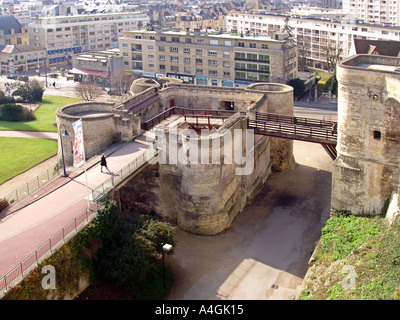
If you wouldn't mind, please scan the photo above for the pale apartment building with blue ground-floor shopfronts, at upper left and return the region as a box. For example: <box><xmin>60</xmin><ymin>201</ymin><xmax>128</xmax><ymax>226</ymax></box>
<box><xmin>28</xmin><ymin>12</ymin><xmax>149</xmax><ymax>64</ymax></box>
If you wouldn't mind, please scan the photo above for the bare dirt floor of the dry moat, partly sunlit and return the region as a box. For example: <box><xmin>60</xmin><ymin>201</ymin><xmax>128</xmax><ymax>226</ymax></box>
<box><xmin>79</xmin><ymin>141</ymin><xmax>333</xmax><ymax>300</ymax></box>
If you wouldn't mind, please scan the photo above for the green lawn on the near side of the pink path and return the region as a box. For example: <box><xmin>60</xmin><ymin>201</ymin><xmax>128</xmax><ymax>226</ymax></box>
<box><xmin>0</xmin><ymin>137</ymin><xmax>58</xmax><ymax>184</ymax></box>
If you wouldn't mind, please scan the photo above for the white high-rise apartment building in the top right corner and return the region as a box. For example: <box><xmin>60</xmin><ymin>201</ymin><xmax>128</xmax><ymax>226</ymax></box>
<box><xmin>342</xmin><ymin>0</ymin><xmax>400</xmax><ymax>26</ymax></box>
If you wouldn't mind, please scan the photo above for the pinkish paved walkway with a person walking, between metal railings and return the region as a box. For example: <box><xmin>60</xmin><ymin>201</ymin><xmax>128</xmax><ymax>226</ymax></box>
<box><xmin>0</xmin><ymin>135</ymin><xmax>152</xmax><ymax>277</ymax></box>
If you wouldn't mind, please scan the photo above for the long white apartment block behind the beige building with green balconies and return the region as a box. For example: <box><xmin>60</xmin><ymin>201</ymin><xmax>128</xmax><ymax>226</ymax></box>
<box><xmin>225</xmin><ymin>11</ymin><xmax>400</xmax><ymax>70</ymax></box>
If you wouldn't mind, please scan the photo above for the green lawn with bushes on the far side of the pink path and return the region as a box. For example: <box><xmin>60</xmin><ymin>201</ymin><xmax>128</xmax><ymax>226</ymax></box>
<box><xmin>0</xmin><ymin>96</ymin><xmax>81</xmax><ymax>132</ymax></box>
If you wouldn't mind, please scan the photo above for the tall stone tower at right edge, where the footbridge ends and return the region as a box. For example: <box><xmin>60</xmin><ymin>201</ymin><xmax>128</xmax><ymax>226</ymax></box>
<box><xmin>332</xmin><ymin>55</ymin><xmax>400</xmax><ymax>215</ymax></box>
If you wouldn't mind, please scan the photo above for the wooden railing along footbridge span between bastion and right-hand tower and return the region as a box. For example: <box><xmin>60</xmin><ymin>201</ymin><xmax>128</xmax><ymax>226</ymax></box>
<box><xmin>249</xmin><ymin>119</ymin><xmax>337</xmax><ymax>145</ymax></box>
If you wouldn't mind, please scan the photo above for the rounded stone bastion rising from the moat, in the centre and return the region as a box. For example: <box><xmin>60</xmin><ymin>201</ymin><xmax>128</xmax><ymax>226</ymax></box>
<box><xmin>156</xmin><ymin>114</ymin><xmax>271</xmax><ymax>235</ymax></box>
